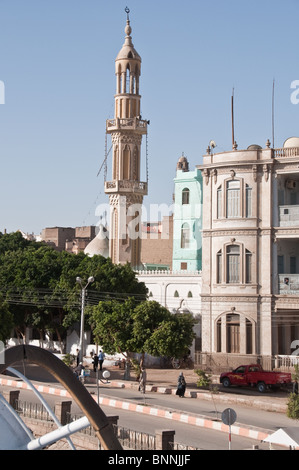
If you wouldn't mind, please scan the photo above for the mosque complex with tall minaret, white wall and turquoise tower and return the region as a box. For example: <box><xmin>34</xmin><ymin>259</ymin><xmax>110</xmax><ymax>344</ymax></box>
<box><xmin>84</xmin><ymin>10</ymin><xmax>202</xmax><ymax>360</ymax></box>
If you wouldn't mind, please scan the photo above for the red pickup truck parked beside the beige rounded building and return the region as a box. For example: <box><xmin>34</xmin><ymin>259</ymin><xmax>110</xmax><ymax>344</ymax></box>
<box><xmin>220</xmin><ymin>364</ymin><xmax>292</xmax><ymax>393</ymax></box>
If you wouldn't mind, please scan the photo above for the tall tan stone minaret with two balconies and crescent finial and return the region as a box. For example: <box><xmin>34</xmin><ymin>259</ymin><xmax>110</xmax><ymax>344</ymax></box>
<box><xmin>105</xmin><ymin>8</ymin><xmax>148</xmax><ymax>268</ymax></box>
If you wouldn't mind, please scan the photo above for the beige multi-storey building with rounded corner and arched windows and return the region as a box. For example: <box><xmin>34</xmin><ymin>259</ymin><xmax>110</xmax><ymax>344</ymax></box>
<box><xmin>198</xmin><ymin>142</ymin><xmax>299</xmax><ymax>364</ymax></box>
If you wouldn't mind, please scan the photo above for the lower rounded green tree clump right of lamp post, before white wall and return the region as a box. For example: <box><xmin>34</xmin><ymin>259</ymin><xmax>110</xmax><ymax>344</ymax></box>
<box><xmin>88</xmin><ymin>299</ymin><xmax>196</xmax><ymax>365</ymax></box>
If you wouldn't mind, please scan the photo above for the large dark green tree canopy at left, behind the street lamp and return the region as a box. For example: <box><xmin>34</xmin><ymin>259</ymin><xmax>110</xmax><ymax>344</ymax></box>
<box><xmin>0</xmin><ymin>233</ymin><xmax>147</xmax><ymax>344</ymax></box>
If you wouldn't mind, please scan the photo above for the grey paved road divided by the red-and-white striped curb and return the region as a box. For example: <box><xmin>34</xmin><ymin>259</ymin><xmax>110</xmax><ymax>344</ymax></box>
<box><xmin>2</xmin><ymin>364</ymin><xmax>294</xmax><ymax>450</ymax></box>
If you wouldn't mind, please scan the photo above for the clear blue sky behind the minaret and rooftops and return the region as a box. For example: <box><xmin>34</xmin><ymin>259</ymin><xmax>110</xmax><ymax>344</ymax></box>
<box><xmin>0</xmin><ymin>0</ymin><xmax>299</xmax><ymax>234</ymax></box>
